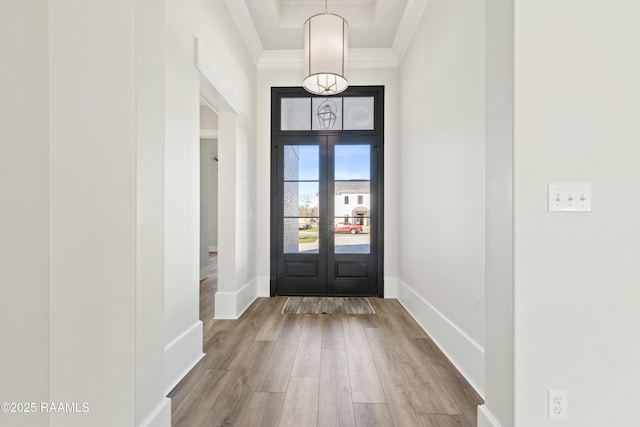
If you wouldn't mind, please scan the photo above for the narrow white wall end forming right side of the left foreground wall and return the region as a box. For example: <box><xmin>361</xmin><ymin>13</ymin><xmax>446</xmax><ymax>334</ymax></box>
<box><xmin>135</xmin><ymin>0</ymin><xmax>171</xmax><ymax>427</ymax></box>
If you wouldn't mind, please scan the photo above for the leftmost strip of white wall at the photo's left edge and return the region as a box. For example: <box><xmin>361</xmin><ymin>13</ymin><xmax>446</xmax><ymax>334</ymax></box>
<box><xmin>0</xmin><ymin>1</ymin><xmax>49</xmax><ymax>426</ymax></box>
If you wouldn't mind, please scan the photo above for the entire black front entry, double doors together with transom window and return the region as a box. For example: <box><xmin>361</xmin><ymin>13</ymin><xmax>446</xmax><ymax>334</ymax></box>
<box><xmin>271</xmin><ymin>86</ymin><xmax>384</xmax><ymax>297</ymax></box>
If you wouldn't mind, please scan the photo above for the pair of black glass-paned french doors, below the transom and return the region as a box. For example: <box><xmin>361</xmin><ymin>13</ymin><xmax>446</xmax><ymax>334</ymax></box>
<box><xmin>271</xmin><ymin>86</ymin><xmax>383</xmax><ymax>296</ymax></box>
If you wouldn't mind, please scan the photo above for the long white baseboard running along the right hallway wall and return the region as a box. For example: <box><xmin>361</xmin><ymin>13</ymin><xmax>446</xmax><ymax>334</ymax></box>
<box><xmin>398</xmin><ymin>279</ymin><xmax>484</xmax><ymax>396</ymax></box>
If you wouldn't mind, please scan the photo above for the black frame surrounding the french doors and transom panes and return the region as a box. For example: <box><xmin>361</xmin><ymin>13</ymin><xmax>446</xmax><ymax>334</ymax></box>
<box><xmin>269</xmin><ymin>86</ymin><xmax>384</xmax><ymax>298</ymax></box>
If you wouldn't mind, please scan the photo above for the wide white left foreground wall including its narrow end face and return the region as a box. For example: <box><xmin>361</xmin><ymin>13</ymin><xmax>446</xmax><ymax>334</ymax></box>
<box><xmin>49</xmin><ymin>0</ymin><xmax>168</xmax><ymax>426</ymax></box>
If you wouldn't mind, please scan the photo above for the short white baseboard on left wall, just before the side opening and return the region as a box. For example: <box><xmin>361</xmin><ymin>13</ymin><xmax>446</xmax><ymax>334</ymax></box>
<box><xmin>164</xmin><ymin>320</ymin><xmax>204</xmax><ymax>396</ymax></box>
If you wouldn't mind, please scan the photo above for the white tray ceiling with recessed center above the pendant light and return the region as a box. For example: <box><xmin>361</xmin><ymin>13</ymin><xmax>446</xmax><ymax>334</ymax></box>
<box><xmin>225</xmin><ymin>0</ymin><xmax>428</xmax><ymax>64</ymax></box>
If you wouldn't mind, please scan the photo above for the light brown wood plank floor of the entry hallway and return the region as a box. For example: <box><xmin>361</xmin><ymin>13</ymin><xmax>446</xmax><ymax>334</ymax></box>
<box><xmin>169</xmin><ymin>297</ymin><xmax>482</xmax><ymax>427</ymax></box>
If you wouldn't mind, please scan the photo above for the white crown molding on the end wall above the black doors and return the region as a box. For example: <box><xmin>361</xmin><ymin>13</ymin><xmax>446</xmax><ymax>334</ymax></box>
<box><xmin>258</xmin><ymin>48</ymin><xmax>400</xmax><ymax>70</ymax></box>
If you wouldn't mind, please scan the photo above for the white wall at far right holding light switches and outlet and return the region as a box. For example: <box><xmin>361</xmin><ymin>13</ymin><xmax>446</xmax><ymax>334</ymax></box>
<box><xmin>514</xmin><ymin>0</ymin><xmax>640</xmax><ymax>427</ymax></box>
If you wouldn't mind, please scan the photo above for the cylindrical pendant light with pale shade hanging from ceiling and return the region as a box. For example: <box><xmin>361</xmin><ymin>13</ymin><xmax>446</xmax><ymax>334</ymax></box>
<box><xmin>302</xmin><ymin>0</ymin><xmax>349</xmax><ymax>95</ymax></box>
